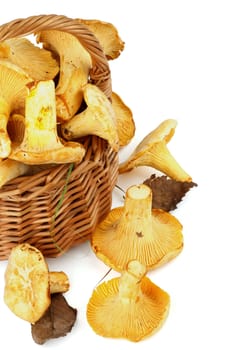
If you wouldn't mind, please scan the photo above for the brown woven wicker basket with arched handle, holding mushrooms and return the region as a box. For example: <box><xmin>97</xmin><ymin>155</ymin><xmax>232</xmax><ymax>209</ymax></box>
<box><xmin>0</xmin><ymin>15</ymin><xmax>118</xmax><ymax>260</ymax></box>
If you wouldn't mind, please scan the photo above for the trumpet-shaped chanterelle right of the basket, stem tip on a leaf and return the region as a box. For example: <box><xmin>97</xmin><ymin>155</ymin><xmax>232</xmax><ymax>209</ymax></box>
<box><xmin>119</xmin><ymin>119</ymin><xmax>192</xmax><ymax>182</ymax></box>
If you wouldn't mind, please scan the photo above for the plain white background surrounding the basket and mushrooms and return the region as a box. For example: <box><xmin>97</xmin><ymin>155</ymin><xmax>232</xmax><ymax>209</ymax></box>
<box><xmin>0</xmin><ymin>0</ymin><xmax>242</xmax><ymax>350</ymax></box>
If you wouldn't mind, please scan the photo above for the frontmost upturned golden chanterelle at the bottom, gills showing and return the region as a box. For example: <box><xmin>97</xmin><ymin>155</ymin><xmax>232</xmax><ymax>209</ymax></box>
<box><xmin>87</xmin><ymin>260</ymin><xmax>170</xmax><ymax>342</ymax></box>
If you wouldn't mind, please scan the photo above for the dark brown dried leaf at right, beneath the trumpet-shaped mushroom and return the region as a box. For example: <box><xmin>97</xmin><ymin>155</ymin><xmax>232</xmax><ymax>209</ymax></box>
<box><xmin>144</xmin><ymin>174</ymin><xmax>197</xmax><ymax>212</ymax></box>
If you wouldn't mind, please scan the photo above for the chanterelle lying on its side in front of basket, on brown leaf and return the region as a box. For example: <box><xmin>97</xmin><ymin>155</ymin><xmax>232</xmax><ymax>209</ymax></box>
<box><xmin>4</xmin><ymin>243</ymin><xmax>69</xmax><ymax>323</ymax></box>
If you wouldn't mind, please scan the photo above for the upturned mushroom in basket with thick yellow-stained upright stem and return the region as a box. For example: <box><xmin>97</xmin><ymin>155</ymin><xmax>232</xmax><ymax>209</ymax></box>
<box><xmin>9</xmin><ymin>80</ymin><xmax>85</xmax><ymax>164</ymax></box>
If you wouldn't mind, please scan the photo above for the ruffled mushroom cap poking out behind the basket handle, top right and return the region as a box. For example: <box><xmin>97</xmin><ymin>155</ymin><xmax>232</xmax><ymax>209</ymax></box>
<box><xmin>78</xmin><ymin>19</ymin><xmax>124</xmax><ymax>60</ymax></box>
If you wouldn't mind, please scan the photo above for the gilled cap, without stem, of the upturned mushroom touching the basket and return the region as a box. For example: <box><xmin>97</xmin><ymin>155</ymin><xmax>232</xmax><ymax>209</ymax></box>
<box><xmin>91</xmin><ymin>207</ymin><xmax>183</xmax><ymax>271</ymax></box>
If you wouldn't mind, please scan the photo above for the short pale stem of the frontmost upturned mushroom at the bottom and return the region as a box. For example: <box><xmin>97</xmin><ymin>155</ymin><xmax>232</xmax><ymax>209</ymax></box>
<box><xmin>119</xmin><ymin>260</ymin><xmax>146</xmax><ymax>304</ymax></box>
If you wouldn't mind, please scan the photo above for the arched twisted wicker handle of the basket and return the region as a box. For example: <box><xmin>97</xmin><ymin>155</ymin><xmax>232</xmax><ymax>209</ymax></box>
<box><xmin>0</xmin><ymin>15</ymin><xmax>112</xmax><ymax>99</ymax></box>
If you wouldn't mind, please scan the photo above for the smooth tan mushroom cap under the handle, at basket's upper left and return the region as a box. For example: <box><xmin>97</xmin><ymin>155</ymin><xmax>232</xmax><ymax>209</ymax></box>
<box><xmin>0</xmin><ymin>38</ymin><xmax>59</xmax><ymax>80</ymax></box>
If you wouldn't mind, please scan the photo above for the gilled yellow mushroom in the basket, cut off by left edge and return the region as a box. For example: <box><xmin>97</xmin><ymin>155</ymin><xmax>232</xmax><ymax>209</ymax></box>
<box><xmin>0</xmin><ymin>59</ymin><xmax>32</xmax><ymax>158</ymax></box>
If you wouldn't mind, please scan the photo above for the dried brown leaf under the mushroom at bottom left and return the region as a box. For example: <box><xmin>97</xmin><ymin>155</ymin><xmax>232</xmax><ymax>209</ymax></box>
<box><xmin>31</xmin><ymin>293</ymin><xmax>77</xmax><ymax>345</ymax></box>
